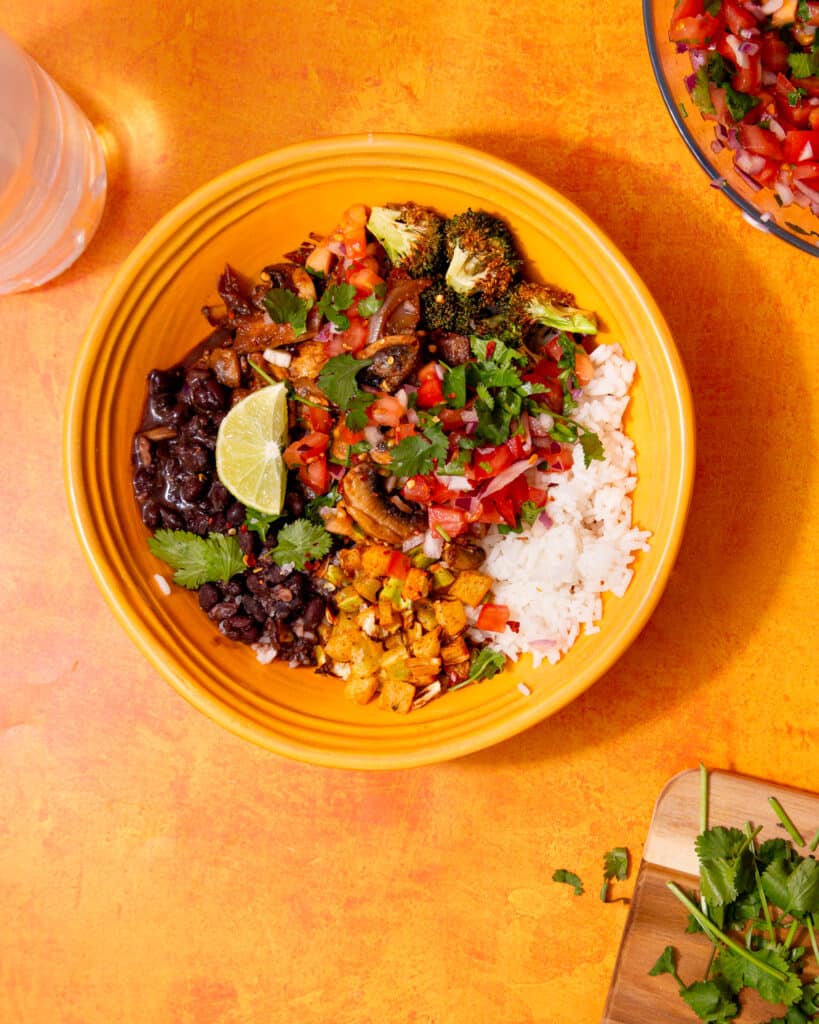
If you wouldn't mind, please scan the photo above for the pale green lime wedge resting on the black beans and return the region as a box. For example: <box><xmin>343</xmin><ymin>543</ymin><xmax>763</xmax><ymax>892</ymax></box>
<box><xmin>216</xmin><ymin>383</ymin><xmax>288</xmax><ymax>515</ymax></box>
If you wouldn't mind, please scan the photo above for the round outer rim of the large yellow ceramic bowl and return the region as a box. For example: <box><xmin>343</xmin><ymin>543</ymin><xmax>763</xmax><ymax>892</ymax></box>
<box><xmin>63</xmin><ymin>132</ymin><xmax>695</xmax><ymax>770</ymax></box>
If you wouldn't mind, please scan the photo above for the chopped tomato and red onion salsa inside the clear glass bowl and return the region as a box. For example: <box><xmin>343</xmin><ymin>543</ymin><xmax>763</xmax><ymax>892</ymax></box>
<box><xmin>670</xmin><ymin>0</ymin><xmax>819</xmax><ymax>213</ymax></box>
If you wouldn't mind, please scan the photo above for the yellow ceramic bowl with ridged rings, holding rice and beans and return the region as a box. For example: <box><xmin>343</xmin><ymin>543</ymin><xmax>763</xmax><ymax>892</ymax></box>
<box><xmin>66</xmin><ymin>135</ymin><xmax>693</xmax><ymax>768</ymax></box>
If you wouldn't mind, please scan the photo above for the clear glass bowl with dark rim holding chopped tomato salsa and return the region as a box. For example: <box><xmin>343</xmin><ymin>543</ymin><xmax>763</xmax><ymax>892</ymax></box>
<box><xmin>643</xmin><ymin>0</ymin><xmax>819</xmax><ymax>256</ymax></box>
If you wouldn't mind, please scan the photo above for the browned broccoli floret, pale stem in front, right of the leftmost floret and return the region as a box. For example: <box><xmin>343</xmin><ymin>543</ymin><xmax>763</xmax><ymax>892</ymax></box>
<box><xmin>444</xmin><ymin>210</ymin><xmax>520</xmax><ymax>302</ymax></box>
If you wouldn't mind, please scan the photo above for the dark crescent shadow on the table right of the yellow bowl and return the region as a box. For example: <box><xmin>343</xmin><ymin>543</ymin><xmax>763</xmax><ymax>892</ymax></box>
<box><xmin>455</xmin><ymin>128</ymin><xmax>816</xmax><ymax>767</ymax></box>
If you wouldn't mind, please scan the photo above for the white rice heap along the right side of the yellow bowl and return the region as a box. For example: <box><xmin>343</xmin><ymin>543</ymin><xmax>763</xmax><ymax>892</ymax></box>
<box><xmin>471</xmin><ymin>345</ymin><xmax>650</xmax><ymax>668</ymax></box>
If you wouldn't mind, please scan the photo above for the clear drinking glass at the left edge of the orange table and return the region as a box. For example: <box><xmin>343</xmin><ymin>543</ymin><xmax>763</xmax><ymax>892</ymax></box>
<box><xmin>0</xmin><ymin>31</ymin><xmax>106</xmax><ymax>295</ymax></box>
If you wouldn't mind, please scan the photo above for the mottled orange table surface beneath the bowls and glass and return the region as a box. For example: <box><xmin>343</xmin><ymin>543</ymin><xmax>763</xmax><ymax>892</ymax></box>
<box><xmin>0</xmin><ymin>0</ymin><xmax>819</xmax><ymax>1024</ymax></box>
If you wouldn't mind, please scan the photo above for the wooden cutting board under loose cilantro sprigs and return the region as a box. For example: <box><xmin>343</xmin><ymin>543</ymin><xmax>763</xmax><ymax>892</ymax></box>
<box><xmin>602</xmin><ymin>770</ymin><xmax>819</xmax><ymax>1024</ymax></box>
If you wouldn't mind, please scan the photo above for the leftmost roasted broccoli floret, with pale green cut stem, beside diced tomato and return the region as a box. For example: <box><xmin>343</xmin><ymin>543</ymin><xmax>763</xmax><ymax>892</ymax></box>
<box><xmin>367</xmin><ymin>203</ymin><xmax>443</xmax><ymax>278</ymax></box>
